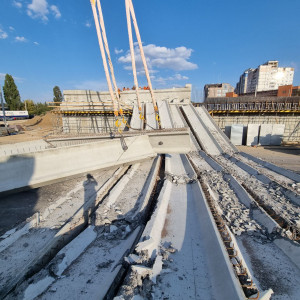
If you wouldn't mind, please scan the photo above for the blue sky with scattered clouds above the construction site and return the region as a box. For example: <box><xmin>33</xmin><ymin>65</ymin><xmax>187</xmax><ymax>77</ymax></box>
<box><xmin>0</xmin><ymin>0</ymin><xmax>300</xmax><ymax>102</ymax></box>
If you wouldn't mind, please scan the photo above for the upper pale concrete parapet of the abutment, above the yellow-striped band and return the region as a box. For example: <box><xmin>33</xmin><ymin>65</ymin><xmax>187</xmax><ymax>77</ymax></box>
<box><xmin>64</xmin><ymin>84</ymin><xmax>192</xmax><ymax>105</ymax></box>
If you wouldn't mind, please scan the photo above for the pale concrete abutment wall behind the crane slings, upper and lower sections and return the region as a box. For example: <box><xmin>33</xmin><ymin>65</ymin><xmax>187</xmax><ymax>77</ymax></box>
<box><xmin>60</xmin><ymin>84</ymin><xmax>192</xmax><ymax>134</ymax></box>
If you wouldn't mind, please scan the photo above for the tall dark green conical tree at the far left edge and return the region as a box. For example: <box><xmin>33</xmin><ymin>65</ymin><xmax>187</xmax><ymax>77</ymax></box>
<box><xmin>3</xmin><ymin>74</ymin><xmax>22</xmax><ymax>110</ymax></box>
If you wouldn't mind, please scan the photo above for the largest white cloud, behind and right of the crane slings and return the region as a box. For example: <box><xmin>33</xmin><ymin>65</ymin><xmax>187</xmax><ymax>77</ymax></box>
<box><xmin>118</xmin><ymin>44</ymin><xmax>198</xmax><ymax>71</ymax></box>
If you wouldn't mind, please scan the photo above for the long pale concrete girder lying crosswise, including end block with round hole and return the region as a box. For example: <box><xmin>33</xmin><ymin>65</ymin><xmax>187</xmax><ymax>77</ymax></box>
<box><xmin>0</xmin><ymin>129</ymin><xmax>191</xmax><ymax>193</ymax></box>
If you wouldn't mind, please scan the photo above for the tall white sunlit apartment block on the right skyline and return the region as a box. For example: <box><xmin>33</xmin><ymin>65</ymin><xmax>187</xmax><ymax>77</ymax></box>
<box><xmin>236</xmin><ymin>60</ymin><xmax>294</xmax><ymax>94</ymax></box>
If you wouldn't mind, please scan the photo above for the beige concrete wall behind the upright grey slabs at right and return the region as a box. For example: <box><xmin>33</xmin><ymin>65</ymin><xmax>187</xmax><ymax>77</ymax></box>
<box><xmin>213</xmin><ymin>115</ymin><xmax>300</xmax><ymax>143</ymax></box>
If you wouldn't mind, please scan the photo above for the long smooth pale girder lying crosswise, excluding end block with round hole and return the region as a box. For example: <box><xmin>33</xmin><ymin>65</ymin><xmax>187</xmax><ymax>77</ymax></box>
<box><xmin>0</xmin><ymin>135</ymin><xmax>156</xmax><ymax>192</ymax></box>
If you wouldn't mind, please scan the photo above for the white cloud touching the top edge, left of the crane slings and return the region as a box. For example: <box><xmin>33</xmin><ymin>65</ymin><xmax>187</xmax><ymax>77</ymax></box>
<box><xmin>27</xmin><ymin>0</ymin><xmax>61</xmax><ymax>22</ymax></box>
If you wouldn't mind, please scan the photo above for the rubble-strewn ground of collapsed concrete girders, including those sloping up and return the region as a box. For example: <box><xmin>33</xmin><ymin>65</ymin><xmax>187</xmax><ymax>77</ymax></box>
<box><xmin>0</xmin><ymin>105</ymin><xmax>300</xmax><ymax>300</ymax></box>
